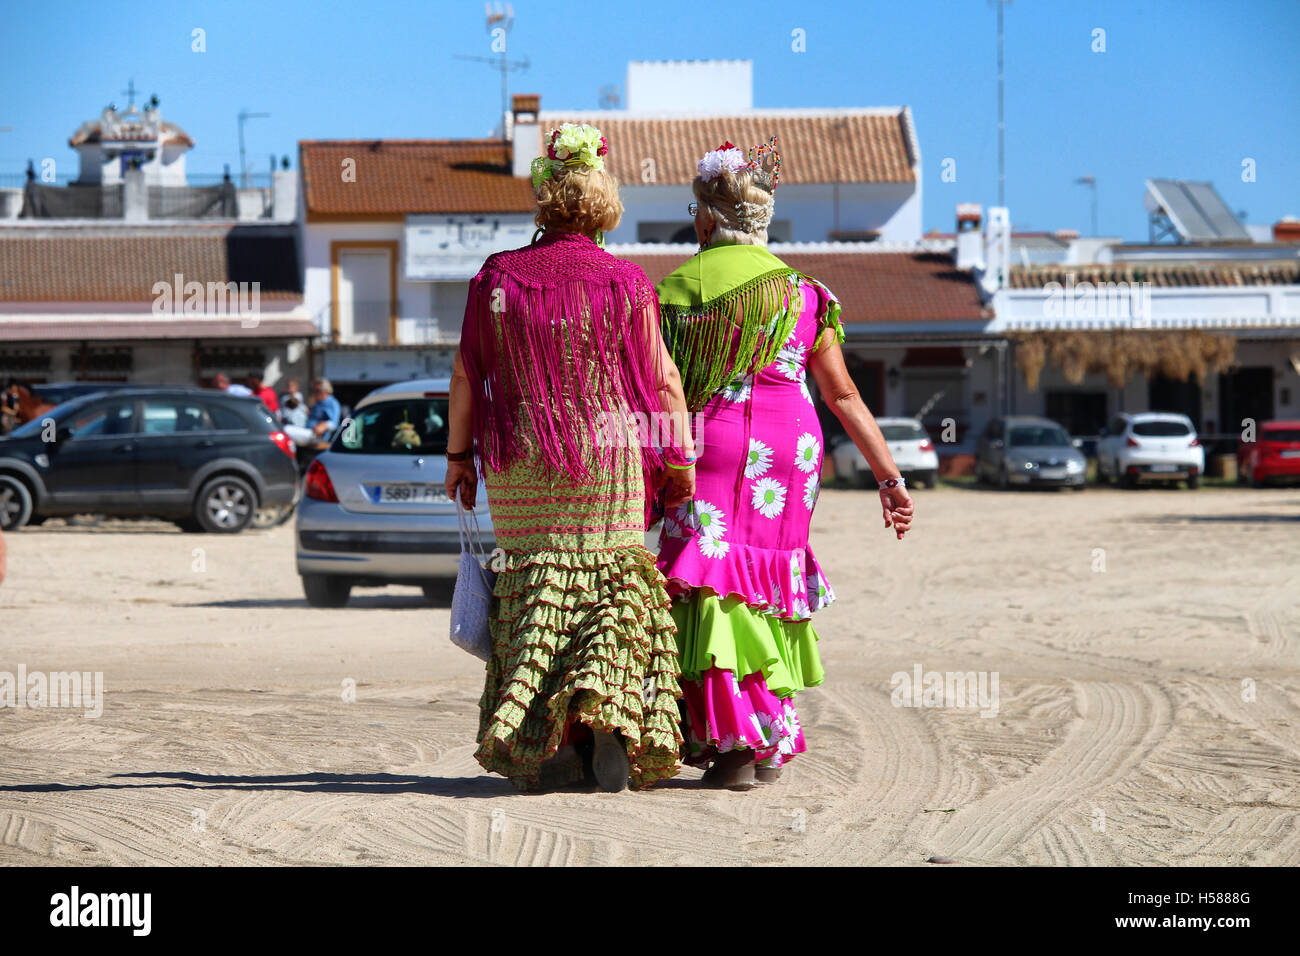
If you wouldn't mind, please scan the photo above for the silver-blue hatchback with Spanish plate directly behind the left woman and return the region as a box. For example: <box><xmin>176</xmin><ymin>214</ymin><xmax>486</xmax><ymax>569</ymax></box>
<box><xmin>295</xmin><ymin>378</ymin><xmax>495</xmax><ymax>607</ymax></box>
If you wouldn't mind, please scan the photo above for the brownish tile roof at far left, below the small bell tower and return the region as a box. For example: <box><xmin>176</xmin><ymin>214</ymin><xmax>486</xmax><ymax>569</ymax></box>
<box><xmin>0</xmin><ymin>224</ymin><xmax>303</xmax><ymax>302</ymax></box>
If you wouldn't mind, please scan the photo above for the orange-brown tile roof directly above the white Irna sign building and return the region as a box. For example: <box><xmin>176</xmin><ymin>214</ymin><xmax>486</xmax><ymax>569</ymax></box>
<box><xmin>298</xmin><ymin>139</ymin><xmax>537</xmax><ymax>221</ymax></box>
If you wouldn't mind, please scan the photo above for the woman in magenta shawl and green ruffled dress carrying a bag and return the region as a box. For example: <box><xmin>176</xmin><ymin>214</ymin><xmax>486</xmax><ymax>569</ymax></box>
<box><xmin>447</xmin><ymin>125</ymin><xmax>693</xmax><ymax>791</ymax></box>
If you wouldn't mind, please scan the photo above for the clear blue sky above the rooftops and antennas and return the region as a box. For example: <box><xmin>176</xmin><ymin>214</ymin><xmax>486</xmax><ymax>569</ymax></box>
<box><xmin>0</xmin><ymin>0</ymin><xmax>1300</xmax><ymax>241</ymax></box>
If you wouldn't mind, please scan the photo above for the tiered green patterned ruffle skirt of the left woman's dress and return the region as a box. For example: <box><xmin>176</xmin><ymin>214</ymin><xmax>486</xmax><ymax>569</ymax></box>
<box><xmin>475</xmin><ymin>546</ymin><xmax>683</xmax><ymax>790</ymax></box>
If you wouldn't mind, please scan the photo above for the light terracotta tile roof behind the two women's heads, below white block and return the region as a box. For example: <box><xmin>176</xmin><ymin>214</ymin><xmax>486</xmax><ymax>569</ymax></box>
<box><xmin>540</xmin><ymin>107</ymin><xmax>917</xmax><ymax>185</ymax></box>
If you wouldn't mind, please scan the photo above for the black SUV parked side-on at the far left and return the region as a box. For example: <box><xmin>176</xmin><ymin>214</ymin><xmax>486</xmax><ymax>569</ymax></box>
<box><xmin>0</xmin><ymin>388</ymin><xmax>298</xmax><ymax>533</ymax></box>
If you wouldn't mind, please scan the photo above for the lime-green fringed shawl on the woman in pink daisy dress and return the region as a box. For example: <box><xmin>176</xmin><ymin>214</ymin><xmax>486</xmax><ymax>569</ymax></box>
<box><xmin>655</xmin><ymin>245</ymin><xmax>841</xmax><ymax>411</ymax></box>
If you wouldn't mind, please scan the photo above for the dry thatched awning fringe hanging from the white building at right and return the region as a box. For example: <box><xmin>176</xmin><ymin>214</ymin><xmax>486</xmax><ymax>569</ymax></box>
<box><xmin>1009</xmin><ymin>329</ymin><xmax>1236</xmax><ymax>392</ymax></box>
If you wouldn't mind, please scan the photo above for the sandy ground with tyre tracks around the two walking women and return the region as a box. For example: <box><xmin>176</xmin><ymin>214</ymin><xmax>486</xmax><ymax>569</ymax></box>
<box><xmin>0</xmin><ymin>488</ymin><xmax>1300</xmax><ymax>865</ymax></box>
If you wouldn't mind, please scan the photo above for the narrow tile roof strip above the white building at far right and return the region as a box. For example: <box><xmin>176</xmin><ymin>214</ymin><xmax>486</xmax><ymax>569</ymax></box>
<box><xmin>1008</xmin><ymin>259</ymin><xmax>1300</xmax><ymax>289</ymax></box>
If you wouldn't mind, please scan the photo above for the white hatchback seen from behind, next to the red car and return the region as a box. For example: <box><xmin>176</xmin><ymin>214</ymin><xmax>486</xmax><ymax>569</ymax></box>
<box><xmin>1097</xmin><ymin>411</ymin><xmax>1205</xmax><ymax>488</ymax></box>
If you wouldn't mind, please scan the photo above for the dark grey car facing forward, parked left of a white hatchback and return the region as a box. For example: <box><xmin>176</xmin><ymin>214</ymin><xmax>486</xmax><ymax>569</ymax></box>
<box><xmin>975</xmin><ymin>415</ymin><xmax>1088</xmax><ymax>490</ymax></box>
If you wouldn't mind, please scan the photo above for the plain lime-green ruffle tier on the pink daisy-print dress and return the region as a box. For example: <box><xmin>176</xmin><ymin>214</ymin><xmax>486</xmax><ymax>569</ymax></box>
<box><xmin>672</xmin><ymin>591</ymin><xmax>826</xmax><ymax>700</ymax></box>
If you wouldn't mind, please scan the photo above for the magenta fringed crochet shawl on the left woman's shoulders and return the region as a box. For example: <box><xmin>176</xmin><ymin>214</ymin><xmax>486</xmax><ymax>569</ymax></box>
<box><xmin>460</xmin><ymin>233</ymin><xmax>662</xmax><ymax>481</ymax></box>
